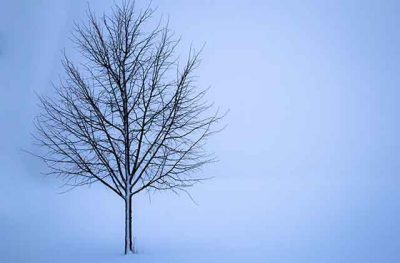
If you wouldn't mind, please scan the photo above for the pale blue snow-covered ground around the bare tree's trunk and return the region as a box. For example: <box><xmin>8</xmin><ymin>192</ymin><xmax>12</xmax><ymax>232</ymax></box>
<box><xmin>0</xmin><ymin>148</ymin><xmax>400</xmax><ymax>263</ymax></box>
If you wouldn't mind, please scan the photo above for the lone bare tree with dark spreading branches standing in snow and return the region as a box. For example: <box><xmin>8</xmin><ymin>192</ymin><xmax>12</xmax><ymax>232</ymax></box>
<box><xmin>35</xmin><ymin>3</ymin><xmax>221</xmax><ymax>254</ymax></box>
